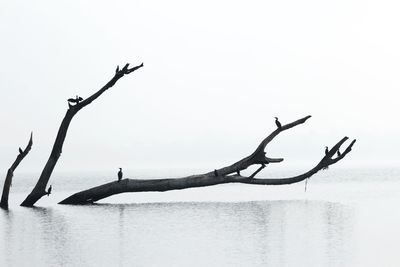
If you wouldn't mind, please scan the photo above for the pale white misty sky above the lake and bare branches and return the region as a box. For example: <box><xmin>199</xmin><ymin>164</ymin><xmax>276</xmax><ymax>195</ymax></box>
<box><xmin>0</xmin><ymin>0</ymin><xmax>400</xmax><ymax>173</ymax></box>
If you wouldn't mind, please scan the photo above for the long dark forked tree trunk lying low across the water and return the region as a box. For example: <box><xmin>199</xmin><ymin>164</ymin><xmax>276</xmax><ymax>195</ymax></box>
<box><xmin>59</xmin><ymin>116</ymin><xmax>356</xmax><ymax>205</ymax></box>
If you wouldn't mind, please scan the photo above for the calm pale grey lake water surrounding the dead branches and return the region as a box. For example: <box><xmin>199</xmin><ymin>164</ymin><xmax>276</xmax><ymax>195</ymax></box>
<box><xmin>0</xmin><ymin>168</ymin><xmax>400</xmax><ymax>267</ymax></box>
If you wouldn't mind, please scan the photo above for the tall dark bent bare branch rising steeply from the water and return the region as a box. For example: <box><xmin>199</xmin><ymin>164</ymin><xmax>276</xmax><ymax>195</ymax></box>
<box><xmin>21</xmin><ymin>63</ymin><xmax>143</xmax><ymax>207</ymax></box>
